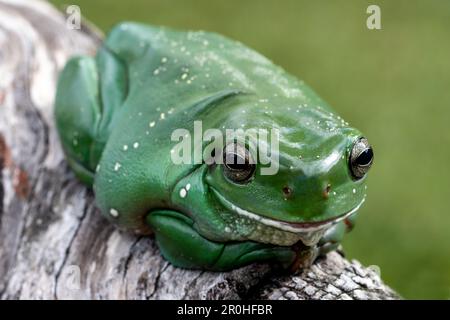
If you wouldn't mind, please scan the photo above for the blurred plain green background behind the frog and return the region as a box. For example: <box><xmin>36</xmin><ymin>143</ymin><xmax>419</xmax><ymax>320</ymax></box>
<box><xmin>51</xmin><ymin>0</ymin><xmax>450</xmax><ymax>299</ymax></box>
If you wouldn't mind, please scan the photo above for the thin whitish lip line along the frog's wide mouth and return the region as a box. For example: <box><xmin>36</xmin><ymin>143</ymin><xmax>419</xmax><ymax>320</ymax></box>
<box><xmin>210</xmin><ymin>187</ymin><xmax>366</xmax><ymax>233</ymax></box>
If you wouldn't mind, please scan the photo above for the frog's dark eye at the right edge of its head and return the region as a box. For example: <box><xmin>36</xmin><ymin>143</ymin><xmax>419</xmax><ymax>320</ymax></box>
<box><xmin>349</xmin><ymin>138</ymin><xmax>373</xmax><ymax>180</ymax></box>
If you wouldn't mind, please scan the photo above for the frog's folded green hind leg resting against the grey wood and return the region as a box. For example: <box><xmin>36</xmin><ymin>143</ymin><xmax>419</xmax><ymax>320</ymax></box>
<box><xmin>55</xmin><ymin>49</ymin><xmax>127</xmax><ymax>185</ymax></box>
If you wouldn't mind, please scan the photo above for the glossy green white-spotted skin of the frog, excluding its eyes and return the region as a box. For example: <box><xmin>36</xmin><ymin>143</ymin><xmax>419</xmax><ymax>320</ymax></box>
<box><xmin>55</xmin><ymin>23</ymin><xmax>372</xmax><ymax>270</ymax></box>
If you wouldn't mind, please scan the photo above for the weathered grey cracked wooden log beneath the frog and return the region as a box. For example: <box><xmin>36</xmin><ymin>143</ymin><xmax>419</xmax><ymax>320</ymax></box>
<box><xmin>0</xmin><ymin>0</ymin><xmax>398</xmax><ymax>299</ymax></box>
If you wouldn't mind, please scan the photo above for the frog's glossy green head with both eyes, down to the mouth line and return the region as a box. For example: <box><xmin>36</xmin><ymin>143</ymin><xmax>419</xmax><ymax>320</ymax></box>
<box><xmin>205</xmin><ymin>96</ymin><xmax>373</xmax><ymax>239</ymax></box>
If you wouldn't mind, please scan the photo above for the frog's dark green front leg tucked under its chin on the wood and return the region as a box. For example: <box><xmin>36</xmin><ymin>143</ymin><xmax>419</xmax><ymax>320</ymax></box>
<box><xmin>147</xmin><ymin>211</ymin><xmax>296</xmax><ymax>271</ymax></box>
